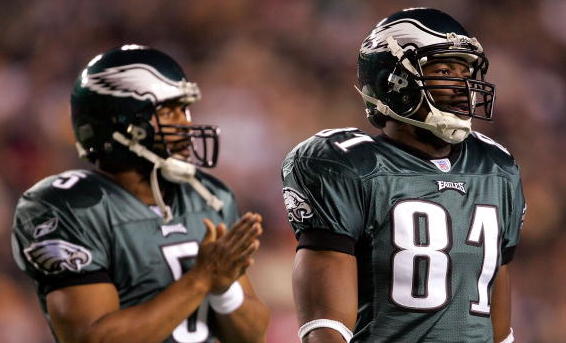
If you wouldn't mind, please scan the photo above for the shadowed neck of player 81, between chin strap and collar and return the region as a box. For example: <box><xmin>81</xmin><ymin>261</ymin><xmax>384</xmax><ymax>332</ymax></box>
<box><xmin>383</xmin><ymin>121</ymin><xmax>452</xmax><ymax>158</ymax></box>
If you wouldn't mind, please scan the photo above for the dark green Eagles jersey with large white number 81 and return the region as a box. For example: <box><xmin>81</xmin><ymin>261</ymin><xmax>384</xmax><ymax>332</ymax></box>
<box><xmin>282</xmin><ymin>128</ymin><xmax>525</xmax><ymax>343</ymax></box>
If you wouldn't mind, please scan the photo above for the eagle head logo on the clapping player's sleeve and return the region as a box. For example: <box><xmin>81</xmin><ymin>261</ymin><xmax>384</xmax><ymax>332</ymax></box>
<box><xmin>24</xmin><ymin>239</ymin><xmax>92</xmax><ymax>274</ymax></box>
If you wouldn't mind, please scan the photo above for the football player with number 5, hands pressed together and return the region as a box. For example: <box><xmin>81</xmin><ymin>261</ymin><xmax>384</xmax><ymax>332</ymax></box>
<box><xmin>13</xmin><ymin>45</ymin><xmax>269</xmax><ymax>343</ymax></box>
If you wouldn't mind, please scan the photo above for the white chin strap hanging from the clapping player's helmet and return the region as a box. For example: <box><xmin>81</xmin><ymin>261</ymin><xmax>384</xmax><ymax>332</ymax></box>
<box><xmin>112</xmin><ymin>131</ymin><xmax>224</xmax><ymax>223</ymax></box>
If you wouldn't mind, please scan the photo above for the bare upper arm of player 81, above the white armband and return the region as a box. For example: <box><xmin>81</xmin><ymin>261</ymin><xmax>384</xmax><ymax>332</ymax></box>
<box><xmin>293</xmin><ymin>249</ymin><xmax>358</xmax><ymax>335</ymax></box>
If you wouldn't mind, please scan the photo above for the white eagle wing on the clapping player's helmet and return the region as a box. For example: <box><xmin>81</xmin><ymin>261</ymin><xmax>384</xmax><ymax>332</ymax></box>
<box><xmin>82</xmin><ymin>63</ymin><xmax>200</xmax><ymax>104</ymax></box>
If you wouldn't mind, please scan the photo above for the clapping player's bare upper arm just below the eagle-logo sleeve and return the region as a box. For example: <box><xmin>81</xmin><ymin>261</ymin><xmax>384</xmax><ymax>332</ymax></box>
<box><xmin>47</xmin><ymin>283</ymin><xmax>120</xmax><ymax>343</ymax></box>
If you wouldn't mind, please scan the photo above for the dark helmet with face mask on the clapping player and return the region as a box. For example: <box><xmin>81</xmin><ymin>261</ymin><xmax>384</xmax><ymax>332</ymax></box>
<box><xmin>71</xmin><ymin>45</ymin><xmax>219</xmax><ymax>167</ymax></box>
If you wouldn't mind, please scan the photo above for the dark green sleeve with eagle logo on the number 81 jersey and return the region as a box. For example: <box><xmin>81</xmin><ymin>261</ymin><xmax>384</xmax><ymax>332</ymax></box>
<box><xmin>282</xmin><ymin>158</ymin><xmax>365</xmax><ymax>252</ymax></box>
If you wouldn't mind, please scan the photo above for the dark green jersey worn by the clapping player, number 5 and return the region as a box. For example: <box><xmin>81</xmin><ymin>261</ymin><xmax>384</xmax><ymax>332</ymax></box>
<box><xmin>13</xmin><ymin>170</ymin><xmax>238</xmax><ymax>342</ymax></box>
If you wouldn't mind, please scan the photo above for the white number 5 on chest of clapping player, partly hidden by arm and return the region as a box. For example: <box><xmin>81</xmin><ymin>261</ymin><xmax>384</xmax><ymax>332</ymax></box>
<box><xmin>161</xmin><ymin>241</ymin><xmax>209</xmax><ymax>343</ymax></box>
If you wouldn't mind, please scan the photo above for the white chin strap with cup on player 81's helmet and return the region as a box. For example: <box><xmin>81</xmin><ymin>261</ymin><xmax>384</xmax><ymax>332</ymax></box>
<box><xmin>354</xmin><ymin>86</ymin><xmax>472</xmax><ymax>144</ymax></box>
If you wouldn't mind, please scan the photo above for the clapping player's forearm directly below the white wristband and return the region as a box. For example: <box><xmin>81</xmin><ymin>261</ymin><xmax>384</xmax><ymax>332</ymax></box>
<box><xmin>216</xmin><ymin>295</ymin><xmax>269</xmax><ymax>343</ymax></box>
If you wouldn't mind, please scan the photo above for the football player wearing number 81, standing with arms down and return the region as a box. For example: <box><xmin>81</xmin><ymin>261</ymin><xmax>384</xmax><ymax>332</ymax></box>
<box><xmin>282</xmin><ymin>8</ymin><xmax>525</xmax><ymax>343</ymax></box>
